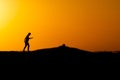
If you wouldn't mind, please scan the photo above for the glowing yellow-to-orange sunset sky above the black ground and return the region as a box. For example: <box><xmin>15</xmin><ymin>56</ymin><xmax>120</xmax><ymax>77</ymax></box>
<box><xmin>0</xmin><ymin>0</ymin><xmax>120</xmax><ymax>51</ymax></box>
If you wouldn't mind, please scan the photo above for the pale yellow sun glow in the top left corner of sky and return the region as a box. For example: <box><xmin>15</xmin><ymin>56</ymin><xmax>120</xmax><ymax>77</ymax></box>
<box><xmin>0</xmin><ymin>0</ymin><xmax>18</xmax><ymax>27</ymax></box>
